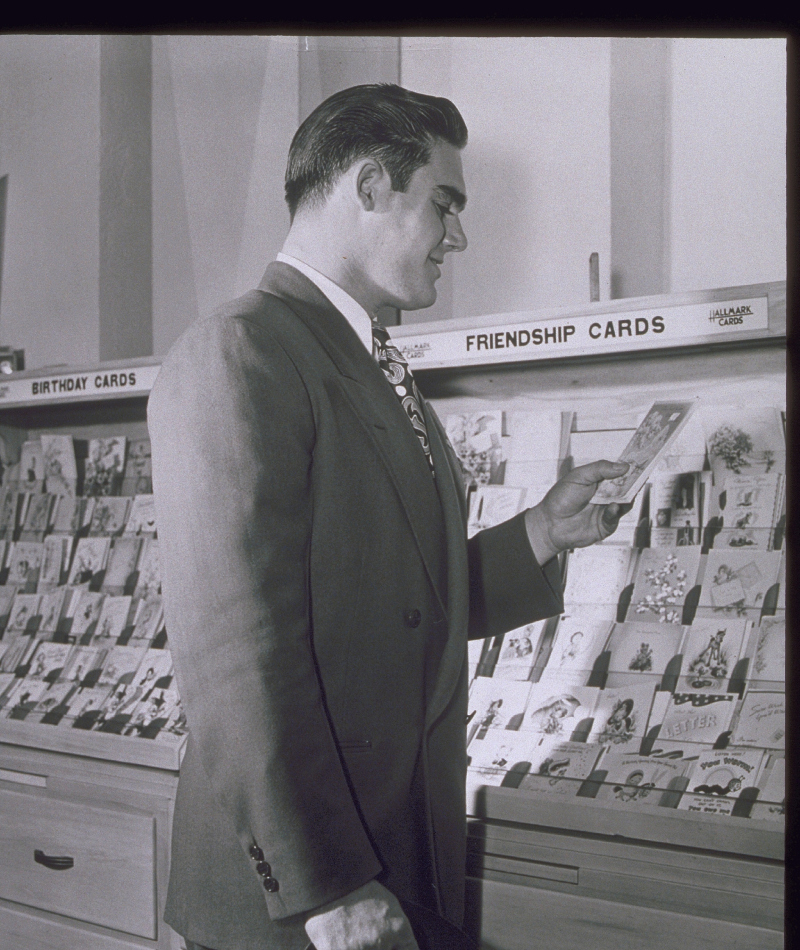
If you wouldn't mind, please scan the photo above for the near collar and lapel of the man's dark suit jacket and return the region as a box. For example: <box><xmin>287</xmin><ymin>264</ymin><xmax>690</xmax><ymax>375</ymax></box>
<box><xmin>259</xmin><ymin>263</ymin><xmax>449</xmax><ymax>613</ymax></box>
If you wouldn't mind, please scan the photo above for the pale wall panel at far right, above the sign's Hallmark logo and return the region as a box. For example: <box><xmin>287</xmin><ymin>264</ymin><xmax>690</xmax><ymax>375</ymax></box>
<box><xmin>670</xmin><ymin>39</ymin><xmax>786</xmax><ymax>291</ymax></box>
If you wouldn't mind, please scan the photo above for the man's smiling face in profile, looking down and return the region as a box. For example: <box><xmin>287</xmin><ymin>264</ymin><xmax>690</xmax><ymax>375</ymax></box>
<box><xmin>368</xmin><ymin>142</ymin><xmax>467</xmax><ymax>310</ymax></box>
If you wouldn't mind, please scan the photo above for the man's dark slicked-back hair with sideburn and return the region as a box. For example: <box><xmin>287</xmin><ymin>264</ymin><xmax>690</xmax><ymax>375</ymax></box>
<box><xmin>285</xmin><ymin>83</ymin><xmax>467</xmax><ymax>218</ymax></box>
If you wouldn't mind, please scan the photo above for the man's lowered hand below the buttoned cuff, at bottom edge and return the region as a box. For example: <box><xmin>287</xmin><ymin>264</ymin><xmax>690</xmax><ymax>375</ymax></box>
<box><xmin>306</xmin><ymin>881</ymin><xmax>419</xmax><ymax>950</ymax></box>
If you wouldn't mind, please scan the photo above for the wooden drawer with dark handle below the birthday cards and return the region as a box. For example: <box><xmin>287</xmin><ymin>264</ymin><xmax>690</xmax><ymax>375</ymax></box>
<box><xmin>0</xmin><ymin>790</ymin><xmax>157</xmax><ymax>940</ymax></box>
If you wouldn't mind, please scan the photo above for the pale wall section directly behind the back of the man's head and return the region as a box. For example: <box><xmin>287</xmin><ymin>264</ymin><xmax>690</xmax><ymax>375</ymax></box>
<box><xmin>153</xmin><ymin>36</ymin><xmax>298</xmax><ymax>356</ymax></box>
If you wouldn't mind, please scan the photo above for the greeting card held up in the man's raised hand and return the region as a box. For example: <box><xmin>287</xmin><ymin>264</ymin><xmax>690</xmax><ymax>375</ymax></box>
<box><xmin>592</xmin><ymin>402</ymin><xmax>694</xmax><ymax>505</ymax></box>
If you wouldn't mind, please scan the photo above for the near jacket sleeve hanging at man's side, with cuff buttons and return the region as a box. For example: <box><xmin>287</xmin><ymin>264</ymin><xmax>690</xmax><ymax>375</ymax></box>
<box><xmin>148</xmin><ymin>317</ymin><xmax>381</xmax><ymax>919</ymax></box>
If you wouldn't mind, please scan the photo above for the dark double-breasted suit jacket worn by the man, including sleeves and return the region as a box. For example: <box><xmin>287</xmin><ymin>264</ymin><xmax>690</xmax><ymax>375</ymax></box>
<box><xmin>148</xmin><ymin>263</ymin><xmax>562</xmax><ymax>950</ymax></box>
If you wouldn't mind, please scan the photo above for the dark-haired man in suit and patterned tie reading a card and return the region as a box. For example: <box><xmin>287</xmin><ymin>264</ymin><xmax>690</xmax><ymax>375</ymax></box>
<box><xmin>149</xmin><ymin>86</ymin><xmax>626</xmax><ymax>950</ymax></box>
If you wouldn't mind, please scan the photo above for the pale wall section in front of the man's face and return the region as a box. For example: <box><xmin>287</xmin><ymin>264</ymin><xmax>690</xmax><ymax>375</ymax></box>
<box><xmin>401</xmin><ymin>37</ymin><xmax>610</xmax><ymax>323</ymax></box>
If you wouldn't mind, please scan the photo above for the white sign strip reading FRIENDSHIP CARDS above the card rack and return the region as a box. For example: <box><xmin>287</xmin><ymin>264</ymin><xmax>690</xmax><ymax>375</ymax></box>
<box><xmin>393</xmin><ymin>296</ymin><xmax>769</xmax><ymax>369</ymax></box>
